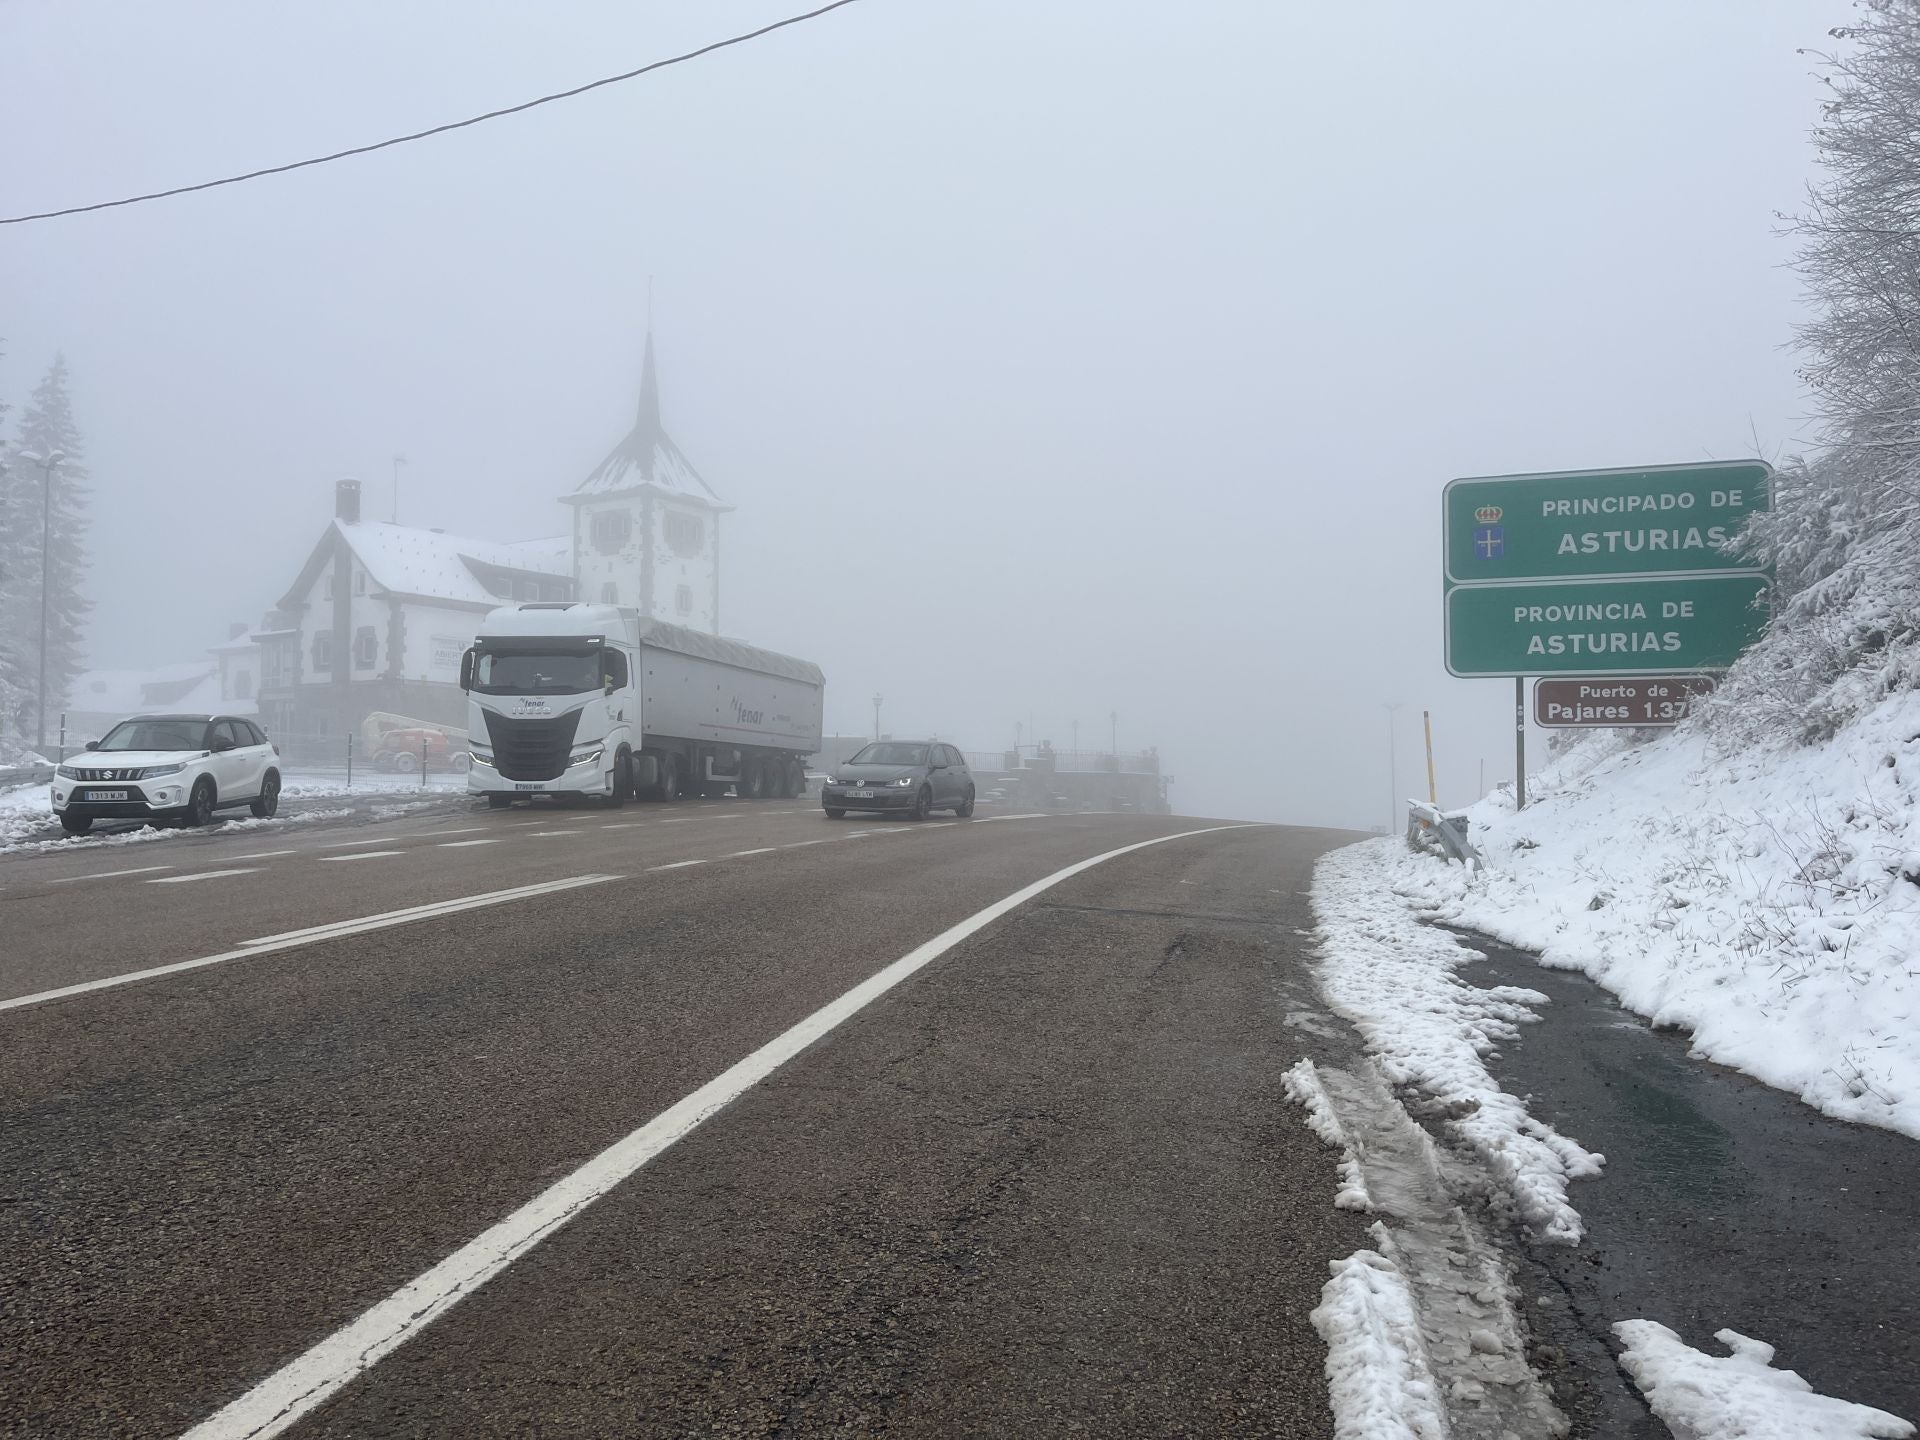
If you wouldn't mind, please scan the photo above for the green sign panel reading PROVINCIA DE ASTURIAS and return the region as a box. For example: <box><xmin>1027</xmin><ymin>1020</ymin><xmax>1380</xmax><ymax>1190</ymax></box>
<box><xmin>1446</xmin><ymin>574</ymin><xmax>1766</xmax><ymax>678</ymax></box>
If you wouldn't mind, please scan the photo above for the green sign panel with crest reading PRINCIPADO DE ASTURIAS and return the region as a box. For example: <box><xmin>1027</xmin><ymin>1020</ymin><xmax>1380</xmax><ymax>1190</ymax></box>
<box><xmin>1442</xmin><ymin>461</ymin><xmax>1774</xmax><ymax>586</ymax></box>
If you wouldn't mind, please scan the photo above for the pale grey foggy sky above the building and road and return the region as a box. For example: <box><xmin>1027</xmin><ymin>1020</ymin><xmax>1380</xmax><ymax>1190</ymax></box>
<box><xmin>0</xmin><ymin>0</ymin><xmax>1849</xmax><ymax>826</ymax></box>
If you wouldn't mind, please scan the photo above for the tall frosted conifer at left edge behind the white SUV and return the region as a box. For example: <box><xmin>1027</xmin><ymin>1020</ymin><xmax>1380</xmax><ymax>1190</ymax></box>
<box><xmin>0</xmin><ymin>355</ymin><xmax>92</xmax><ymax>751</ymax></box>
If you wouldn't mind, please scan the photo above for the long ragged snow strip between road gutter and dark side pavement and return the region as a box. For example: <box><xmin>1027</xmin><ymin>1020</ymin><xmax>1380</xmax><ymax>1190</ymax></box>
<box><xmin>1313</xmin><ymin>852</ymin><xmax>1603</xmax><ymax>1244</ymax></box>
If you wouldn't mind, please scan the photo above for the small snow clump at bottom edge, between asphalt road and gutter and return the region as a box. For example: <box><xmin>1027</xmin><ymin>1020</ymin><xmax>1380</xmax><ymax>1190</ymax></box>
<box><xmin>1309</xmin><ymin>1223</ymin><xmax>1448</xmax><ymax>1440</ymax></box>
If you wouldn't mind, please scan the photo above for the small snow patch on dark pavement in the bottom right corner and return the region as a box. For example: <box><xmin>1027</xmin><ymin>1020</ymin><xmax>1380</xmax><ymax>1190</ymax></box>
<box><xmin>1613</xmin><ymin>1321</ymin><xmax>1914</xmax><ymax>1440</ymax></box>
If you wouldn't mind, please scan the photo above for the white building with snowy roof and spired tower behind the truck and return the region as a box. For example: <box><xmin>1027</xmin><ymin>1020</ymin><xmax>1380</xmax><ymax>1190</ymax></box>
<box><xmin>252</xmin><ymin>334</ymin><xmax>730</xmax><ymax>745</ymax></box>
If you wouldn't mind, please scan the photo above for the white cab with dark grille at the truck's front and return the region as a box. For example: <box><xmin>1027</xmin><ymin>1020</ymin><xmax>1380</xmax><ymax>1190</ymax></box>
<box><xmin>461</xmin><ymin>603</ymin><xmax>639</xmax><ymax>808</ymax></box>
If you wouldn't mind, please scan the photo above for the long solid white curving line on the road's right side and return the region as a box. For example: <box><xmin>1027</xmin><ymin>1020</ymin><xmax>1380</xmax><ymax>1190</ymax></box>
<box><xmin>182</xmin><ymin>826</ymin><xmax>1256</xmax><ymax>1440</ymax></box>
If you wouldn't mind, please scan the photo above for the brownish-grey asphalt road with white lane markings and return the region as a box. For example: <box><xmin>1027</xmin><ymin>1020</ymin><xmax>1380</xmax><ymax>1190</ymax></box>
<box><xmin>0</xmin><ymin>803</ymin><xmax>1367</xmax><ymax>1436</ymax></box>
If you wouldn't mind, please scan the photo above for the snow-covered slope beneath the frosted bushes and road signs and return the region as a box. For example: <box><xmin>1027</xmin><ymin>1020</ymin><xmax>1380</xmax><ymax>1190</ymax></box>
<box><xmin>1379</xmin><ymin>693</ymin><xmax>1920</xmax><ymax>1137</ymax></box>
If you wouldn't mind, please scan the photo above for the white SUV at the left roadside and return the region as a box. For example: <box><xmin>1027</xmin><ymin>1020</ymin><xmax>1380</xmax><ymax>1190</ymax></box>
<box><xmin>54</xmin><ymin>714</ymin><xmax>280</xmax><ymax>835</ymax></box>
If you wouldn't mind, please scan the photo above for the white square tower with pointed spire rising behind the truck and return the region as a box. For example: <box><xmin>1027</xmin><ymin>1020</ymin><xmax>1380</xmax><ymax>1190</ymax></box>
<box><xmin>566</xmin><ymin>328</ymin><xmax>733</xmax><ymax>634</ymax></box>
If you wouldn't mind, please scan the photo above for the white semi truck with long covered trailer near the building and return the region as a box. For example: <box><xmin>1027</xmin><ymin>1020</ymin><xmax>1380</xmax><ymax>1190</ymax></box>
<box><xmin>461</xmin><ymin>601</ymin><xmax>824</xmax><ymax>808</ymax></box>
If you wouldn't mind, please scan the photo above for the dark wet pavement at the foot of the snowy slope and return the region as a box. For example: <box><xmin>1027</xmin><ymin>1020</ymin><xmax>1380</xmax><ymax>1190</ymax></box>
<box><xmin>1461</xmin><ymin>935</ymin><xmax>1920</xmax><ymax>1440</ymax></box>
